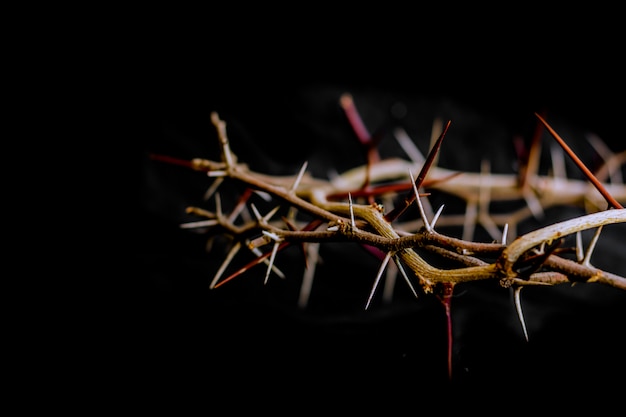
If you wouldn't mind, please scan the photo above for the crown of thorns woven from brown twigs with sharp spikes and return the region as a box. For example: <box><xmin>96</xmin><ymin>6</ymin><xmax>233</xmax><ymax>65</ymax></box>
<box><xmin>153</xmin><ymin>93</ymin><xmax>626</xmax><ymax>376</ymax></box>
